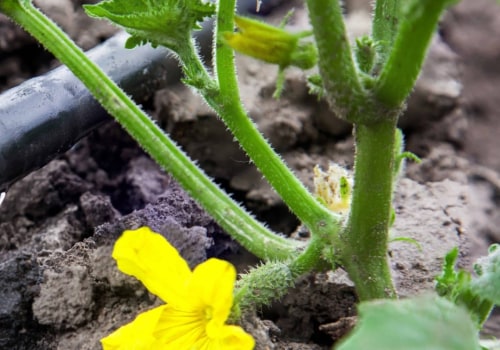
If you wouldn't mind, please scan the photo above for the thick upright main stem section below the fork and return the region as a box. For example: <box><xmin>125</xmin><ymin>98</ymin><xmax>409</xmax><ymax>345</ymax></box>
<box><xmin>338</xmin><ymin>120</ymin><xmax>396</xmax><ymax>301</ymax></box>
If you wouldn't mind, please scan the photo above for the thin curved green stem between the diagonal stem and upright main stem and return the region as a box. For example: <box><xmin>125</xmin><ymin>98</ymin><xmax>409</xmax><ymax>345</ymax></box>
<box><xmin>213</xmin><ymin>0</ymin><xmax>339</xmax><ymax>237</ymax></box>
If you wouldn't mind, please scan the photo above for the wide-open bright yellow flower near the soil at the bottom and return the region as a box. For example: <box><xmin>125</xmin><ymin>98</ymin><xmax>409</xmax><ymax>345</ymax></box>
<box><xmin>101</xmin><ymin>227</ymin><xmax>255</xmax><ymax>350</ymax></box>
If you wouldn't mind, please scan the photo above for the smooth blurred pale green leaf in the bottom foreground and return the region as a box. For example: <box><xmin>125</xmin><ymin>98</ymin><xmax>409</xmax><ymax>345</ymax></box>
<box><xmin>336</xmin><ymin>295</ymin><xmax>480</xmax><ymax>350</ymax></box>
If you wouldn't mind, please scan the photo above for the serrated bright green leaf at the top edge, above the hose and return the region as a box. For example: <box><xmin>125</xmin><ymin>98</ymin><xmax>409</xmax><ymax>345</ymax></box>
<box><xmin>84</xmin><ymin>0</ymin><xmax>215</xmax><ymax>51</ymax></box>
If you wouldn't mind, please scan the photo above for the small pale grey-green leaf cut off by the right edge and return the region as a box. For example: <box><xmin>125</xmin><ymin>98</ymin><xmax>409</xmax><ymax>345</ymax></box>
<box><xmin>470</xmin><ymin>244</ymin><xmax>500</xmax><ymax>305</ymax></box>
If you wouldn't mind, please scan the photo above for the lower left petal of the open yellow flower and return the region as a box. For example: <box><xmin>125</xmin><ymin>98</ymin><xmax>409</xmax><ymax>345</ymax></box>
<box><xmin>101</xmin><ymin>305</ymin><xmax>165</xmax><ymax>350</ymax></box>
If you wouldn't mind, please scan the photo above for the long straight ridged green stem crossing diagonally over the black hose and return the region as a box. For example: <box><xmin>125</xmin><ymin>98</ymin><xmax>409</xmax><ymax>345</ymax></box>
<box><xmin>0</xmin><ymin>0</ymin><xmax>298</xmax><ymax>260</ymax></box>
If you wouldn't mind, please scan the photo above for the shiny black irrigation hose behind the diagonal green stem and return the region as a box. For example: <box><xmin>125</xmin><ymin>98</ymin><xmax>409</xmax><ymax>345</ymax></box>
<box><xmin>0</xmin><ymin>0</ymin><xmax>283</xmax><ymax>192</ymax></box>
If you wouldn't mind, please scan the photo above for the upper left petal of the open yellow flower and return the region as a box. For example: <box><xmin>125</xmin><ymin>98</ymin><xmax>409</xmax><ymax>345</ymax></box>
<box><xmin>113</xmin><ymin>227</ymin><xmax>191</xmax><ymax>302</ymax></box>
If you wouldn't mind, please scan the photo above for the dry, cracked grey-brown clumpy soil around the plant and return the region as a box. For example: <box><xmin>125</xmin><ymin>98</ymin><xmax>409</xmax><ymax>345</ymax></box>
<box><xmin>0</xmin><ymin>0</ymin><xmax>500</xmax><ymax>350</ymax></box>
